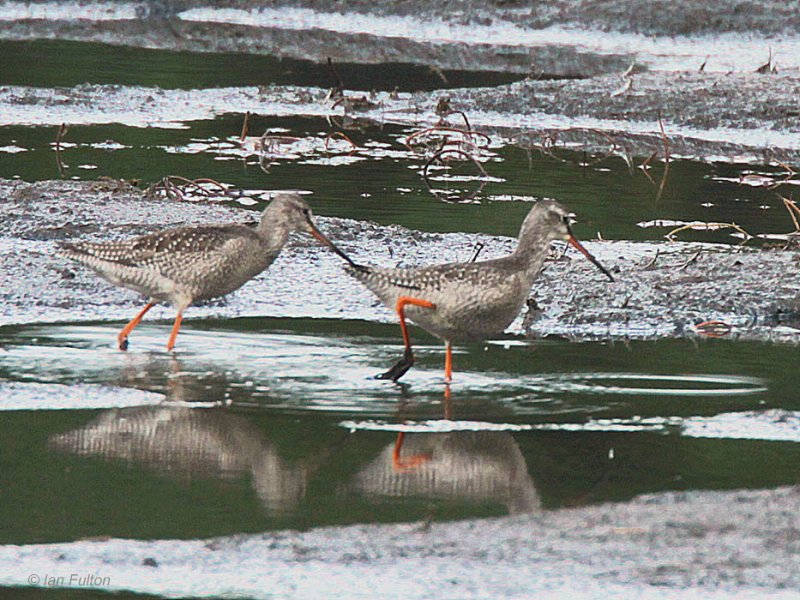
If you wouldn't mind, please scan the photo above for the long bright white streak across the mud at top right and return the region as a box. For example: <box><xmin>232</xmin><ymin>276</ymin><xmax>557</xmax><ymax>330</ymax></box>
<box><xmin>178</xmin><ymin>7</ymin><xmax>800</xmax><ymax>72</ymax></box>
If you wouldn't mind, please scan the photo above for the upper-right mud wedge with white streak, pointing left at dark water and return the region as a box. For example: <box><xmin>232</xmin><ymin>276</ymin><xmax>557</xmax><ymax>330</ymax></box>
<box><xmin>449</xmin><ymin>71</ymin><xmax>800</xmax><ymax>163</ymax></box>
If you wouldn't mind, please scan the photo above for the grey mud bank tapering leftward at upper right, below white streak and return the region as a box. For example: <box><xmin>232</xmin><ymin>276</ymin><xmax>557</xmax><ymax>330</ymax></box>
<box><xmin>449</xmin><ymin>72</ymin><xmax>800</xmax><ymax>156</ymax></box>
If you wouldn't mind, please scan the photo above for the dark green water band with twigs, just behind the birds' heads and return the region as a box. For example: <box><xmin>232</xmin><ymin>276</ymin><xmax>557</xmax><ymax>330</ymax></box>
<box><xmin>0</xmin><ymin>115</ymin><xmax>793</xmax><ymax>243</ymax></box>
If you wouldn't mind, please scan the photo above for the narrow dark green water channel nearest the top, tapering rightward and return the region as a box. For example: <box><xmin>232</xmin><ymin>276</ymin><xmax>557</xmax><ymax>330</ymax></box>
<box><xmin>0</xmin><ymin>40</ymin><xmax>520</xmax><ymax>92</ymax></box>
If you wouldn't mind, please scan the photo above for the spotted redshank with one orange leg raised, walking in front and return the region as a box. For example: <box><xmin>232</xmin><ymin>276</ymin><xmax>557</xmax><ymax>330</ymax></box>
<box><xmin>347</xmin><ymin>200</ymin><xmax>614</xmax><ymax>382</ymax></box>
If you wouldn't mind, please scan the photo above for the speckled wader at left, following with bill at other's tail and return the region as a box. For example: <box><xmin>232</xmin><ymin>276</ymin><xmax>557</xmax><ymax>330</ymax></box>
<box><xmin>60</xmin><ymin>194</ymin><xmax>350</xmax><ymax>350</ymax></box>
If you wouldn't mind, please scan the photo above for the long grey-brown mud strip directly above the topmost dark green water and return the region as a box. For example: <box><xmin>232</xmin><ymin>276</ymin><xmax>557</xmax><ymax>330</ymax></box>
<box><xmin>0</xmin><ymin>18</ymin><xmax>633</xmax><ymax>77</ymax></box>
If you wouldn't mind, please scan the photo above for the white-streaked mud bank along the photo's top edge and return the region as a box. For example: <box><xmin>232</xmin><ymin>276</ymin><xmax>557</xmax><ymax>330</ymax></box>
<box><xmin>0</xmin><ymin>0</ymin><xmax>800</xmax><ymax>77</ymax></box>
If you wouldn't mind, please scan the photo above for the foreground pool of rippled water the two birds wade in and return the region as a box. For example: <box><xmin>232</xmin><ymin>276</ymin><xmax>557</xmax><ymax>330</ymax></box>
<box><xmin>0</xmin><ymin>318</ymin><xmax>800</xmax><ymax>543</ymax></box>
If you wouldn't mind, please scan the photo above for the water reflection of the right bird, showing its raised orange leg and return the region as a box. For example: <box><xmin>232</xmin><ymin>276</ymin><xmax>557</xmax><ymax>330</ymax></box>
<box><xmin>348</xmin><ymin>385</ymin><xmax>541</xmax><ymax>514</ymax></box>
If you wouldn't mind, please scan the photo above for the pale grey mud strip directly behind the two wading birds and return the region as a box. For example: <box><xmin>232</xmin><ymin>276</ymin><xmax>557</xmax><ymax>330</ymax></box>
<box><xmin>0</xmin><ymin>181</ymin><xmax>800</xmax><ymax>342</ymax></box>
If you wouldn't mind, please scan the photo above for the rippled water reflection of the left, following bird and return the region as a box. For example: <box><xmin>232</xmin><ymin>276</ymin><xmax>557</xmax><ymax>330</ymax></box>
<box><xmin>49</xmin><ymin>361</ymin><xmax>317</xmax><ymax>513</ymax></box>
